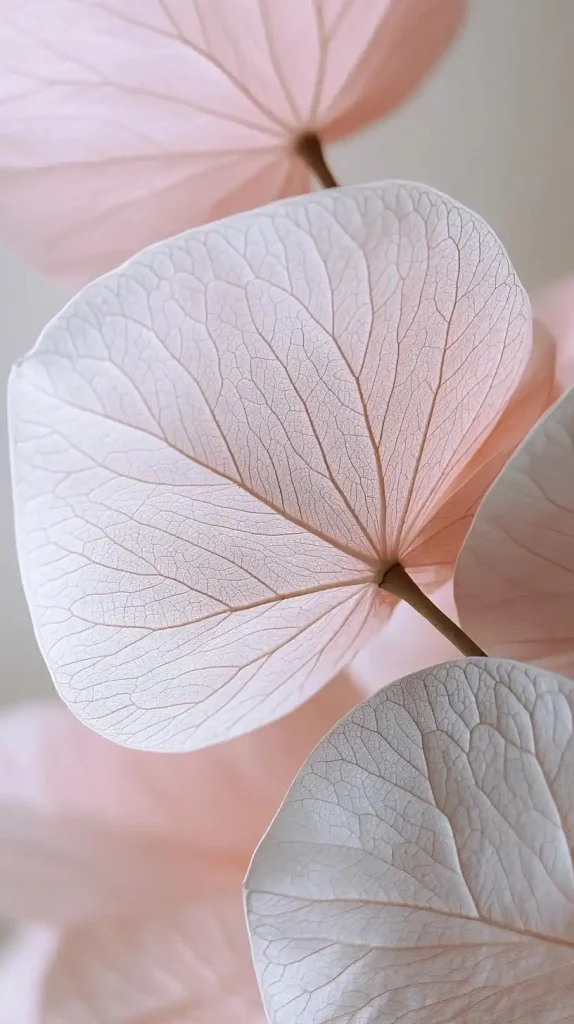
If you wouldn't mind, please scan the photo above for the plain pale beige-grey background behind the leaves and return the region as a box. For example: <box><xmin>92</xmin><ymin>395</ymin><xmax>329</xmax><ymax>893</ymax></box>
<box><xmin>0</xmin><ymin>0</ymin><xmax>574</xmax><ymax>700</ymax></box>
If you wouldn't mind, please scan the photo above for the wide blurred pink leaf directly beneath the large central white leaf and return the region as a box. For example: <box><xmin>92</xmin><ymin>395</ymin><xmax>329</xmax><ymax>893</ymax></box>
<box><xmin>0</xmin><ymin>679</ymin><xmax>357</xmax><ymax>921</ymax></box>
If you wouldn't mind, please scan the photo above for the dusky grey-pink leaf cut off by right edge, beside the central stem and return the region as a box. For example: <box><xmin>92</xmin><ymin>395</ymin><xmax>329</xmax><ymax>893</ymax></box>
<box><xmin>454</xmin><ymin>389</ymin><xmax>574</xmax><ymax>676</ymax></box>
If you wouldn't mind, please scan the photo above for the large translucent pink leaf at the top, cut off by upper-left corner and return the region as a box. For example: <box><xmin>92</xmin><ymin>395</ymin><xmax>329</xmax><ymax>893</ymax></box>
<box><xmin>0</xmin><ymin>0</ymin><xmax>465</xmax><ymax>282</ymax></box>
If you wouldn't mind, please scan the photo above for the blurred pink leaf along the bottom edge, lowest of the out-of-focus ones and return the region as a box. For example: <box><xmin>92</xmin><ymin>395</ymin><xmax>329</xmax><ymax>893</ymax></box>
<box><xmin>42</xmin><ymin>890</ymin><xmax>265</xmax><ymax>1024</ymax></box>
